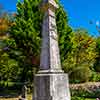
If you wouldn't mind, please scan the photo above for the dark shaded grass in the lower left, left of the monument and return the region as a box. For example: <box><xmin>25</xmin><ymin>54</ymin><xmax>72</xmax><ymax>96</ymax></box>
<box><xmin>0</xmin><ymin>82</ymin><xmax>32</xmax><ymax>98</ymax></box>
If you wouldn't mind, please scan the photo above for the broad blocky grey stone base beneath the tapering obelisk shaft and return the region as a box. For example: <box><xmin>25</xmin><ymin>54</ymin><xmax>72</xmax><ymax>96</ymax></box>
<box><xmin>32</xmin><ymin>73</ymin><xmax>70</xmax><ymax>100</ymax></box>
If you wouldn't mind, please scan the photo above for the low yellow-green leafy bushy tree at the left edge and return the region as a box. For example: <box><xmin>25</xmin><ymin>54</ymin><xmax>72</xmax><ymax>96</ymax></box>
<box><xmin>0</xmin><ymin>52</ymin><xmax>19</xmax><ymax>85</ymax></box>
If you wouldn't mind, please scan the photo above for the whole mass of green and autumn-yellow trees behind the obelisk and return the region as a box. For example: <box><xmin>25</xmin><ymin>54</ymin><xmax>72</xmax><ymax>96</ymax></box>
<box><xmin>0</xmin><ymin>0</ymin><xmax>100</xmax><ymax>85</ymax></box>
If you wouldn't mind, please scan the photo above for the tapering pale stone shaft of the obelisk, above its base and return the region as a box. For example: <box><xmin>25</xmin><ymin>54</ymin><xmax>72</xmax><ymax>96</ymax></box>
<box><xmin>40</xmin><ymin>0</ymin><xmax>61</xmax><ymax>71</ymax></box>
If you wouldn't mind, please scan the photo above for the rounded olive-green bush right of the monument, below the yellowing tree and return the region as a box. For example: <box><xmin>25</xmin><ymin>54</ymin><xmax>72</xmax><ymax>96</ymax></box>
<box><xmin>69</xmin><ymin>67</ymin><xmax>91</xmax><ymax>83</ymax></box>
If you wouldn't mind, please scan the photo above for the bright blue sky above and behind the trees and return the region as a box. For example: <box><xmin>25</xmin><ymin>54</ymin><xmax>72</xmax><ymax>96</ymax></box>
<box><xmin>0</xmin><ymin>0</ymin><xmax>100</xmax><ymax>35</ymax></box>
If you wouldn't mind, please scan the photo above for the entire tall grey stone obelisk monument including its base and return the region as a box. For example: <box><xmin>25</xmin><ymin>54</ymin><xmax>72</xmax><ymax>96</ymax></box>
<box><xmin>33</xmin><ymin>0</ymin><xmax>70</xmax><ymax>100</ymax></box>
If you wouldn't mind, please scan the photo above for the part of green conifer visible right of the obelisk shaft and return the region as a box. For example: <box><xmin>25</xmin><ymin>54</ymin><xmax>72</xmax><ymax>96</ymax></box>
<box><xmin>56</xmin><ymin>5</ymin><xmax>74</xmax><ymax>64</ymax></box>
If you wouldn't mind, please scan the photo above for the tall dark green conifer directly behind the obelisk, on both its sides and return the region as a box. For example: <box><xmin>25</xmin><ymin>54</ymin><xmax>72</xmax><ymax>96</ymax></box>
<box><xmin>10</xmin><ymin>0</ymin><xmax>72</xmax><ymax>83</ymax></box>
